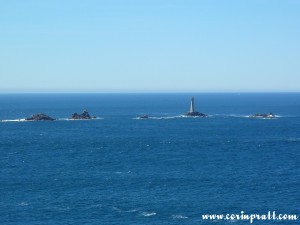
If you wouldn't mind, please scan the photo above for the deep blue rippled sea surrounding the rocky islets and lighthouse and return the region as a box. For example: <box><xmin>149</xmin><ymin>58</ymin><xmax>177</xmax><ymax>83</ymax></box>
<box><xmin>0</xmin><ymin>93</ymin><xmax>300</xmax><ymax>225</ymax></box>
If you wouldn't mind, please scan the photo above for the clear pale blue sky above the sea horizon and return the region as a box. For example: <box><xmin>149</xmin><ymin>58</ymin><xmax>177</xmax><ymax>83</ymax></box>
<box><xmin>0</xmin><ymin>0</ymin><xmax>300</xmax><ymax>92</ymax></box>
